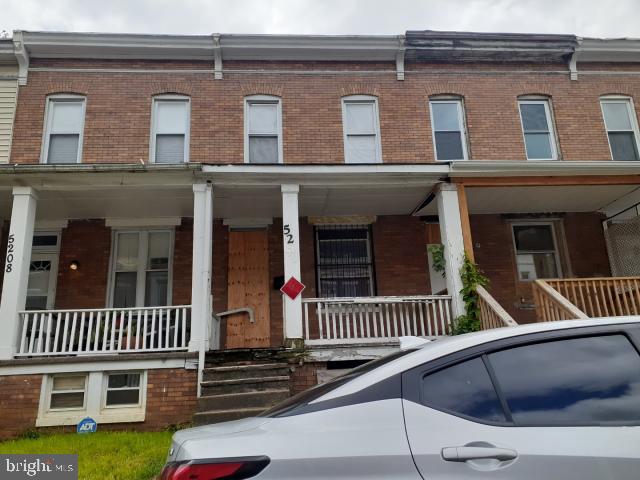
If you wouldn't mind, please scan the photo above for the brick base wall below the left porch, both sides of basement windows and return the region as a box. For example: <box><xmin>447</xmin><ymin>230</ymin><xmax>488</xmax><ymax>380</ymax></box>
<box><xmin>0</xmin><ymin>368</ymin><xmax>198</xmax><ymax>440</ymax></box>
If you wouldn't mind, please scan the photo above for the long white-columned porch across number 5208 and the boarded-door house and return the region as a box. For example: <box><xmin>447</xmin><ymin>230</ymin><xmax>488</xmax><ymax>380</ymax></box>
<box><xmin>0</xmin><ymin>165</ymin><xmax>476</xmax><ymax>359</ymax></box>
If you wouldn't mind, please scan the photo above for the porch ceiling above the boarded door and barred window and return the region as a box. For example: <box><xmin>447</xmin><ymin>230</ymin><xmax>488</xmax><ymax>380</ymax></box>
<box><xmin>213</xmin><ymin>185</ymin><xmax>432</xmax><ymax>218</ymax></box>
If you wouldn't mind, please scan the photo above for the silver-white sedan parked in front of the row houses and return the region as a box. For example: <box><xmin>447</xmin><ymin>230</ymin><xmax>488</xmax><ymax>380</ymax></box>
<box><xmin>161</xmin><ymin>318</ymin><xmax>640</xmax><ymax>480</ymax></box>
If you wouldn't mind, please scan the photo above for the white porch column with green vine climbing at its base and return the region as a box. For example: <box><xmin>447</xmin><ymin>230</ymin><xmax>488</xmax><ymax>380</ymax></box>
<box><xmin>436</xmin><ymin>183</ymin><xmax>465</xmax><ymax>319</ymax></box>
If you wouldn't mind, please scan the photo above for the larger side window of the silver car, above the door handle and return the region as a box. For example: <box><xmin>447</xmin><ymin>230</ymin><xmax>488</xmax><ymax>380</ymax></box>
<box><xmin>488</xmin><ymin>334</ymin><xmax>640</xmax><ymax>426</ymax></box>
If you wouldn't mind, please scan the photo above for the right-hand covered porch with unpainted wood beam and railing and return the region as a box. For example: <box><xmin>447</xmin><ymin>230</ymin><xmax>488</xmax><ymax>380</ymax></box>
<box><xmin>452</xmin><ymin>162</ymin><xmax>640</xmax><ymax>323</ymax></box>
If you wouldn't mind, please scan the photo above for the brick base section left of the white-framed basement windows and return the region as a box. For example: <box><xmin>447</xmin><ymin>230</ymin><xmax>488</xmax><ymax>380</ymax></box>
<box><xmin>0</xmin><ymin>375</ymin><xmax>42</xmax><ymax>440</ymax></box>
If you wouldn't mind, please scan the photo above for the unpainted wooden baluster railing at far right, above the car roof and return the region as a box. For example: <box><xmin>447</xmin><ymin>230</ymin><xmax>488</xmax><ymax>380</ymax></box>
<box><xmin>545</xmin><ymin>277</ymin><xmax>640</xmax><ymax>317</ymax></box>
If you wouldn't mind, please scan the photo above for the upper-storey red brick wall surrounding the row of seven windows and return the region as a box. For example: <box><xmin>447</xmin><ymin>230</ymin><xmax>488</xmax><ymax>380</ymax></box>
<box><xmin>12</xmin><ymin>59</ymin><xmax>640</xmax><ymax>164</ymax></box>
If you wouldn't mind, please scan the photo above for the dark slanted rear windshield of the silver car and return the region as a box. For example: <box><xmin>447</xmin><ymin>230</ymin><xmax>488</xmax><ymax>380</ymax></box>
<box><xmin>260</xmin><ymin>348</ymin><xmax>418</xmax><ymax>417</ymax></box>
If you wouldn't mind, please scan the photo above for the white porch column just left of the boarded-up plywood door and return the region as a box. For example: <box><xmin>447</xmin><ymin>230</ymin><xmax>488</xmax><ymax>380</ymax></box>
<box><xmin>189</xmin><ymin>183</ymin><xmax>217</xmax><ymax>352</ymax></box>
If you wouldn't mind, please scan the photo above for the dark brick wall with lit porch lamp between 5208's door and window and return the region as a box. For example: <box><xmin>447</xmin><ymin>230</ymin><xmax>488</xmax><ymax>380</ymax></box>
<box><xmin>55</xmin><ymin>220</ymin><xmax>111</xmax><ymax>309</ymax></box>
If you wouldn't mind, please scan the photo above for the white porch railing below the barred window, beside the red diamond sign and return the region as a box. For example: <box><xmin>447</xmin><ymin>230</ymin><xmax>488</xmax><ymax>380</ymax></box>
<box><xmin>302</xmin><ymin>295</ymin><xmax>451</xmax><ymax>345</ymax></box>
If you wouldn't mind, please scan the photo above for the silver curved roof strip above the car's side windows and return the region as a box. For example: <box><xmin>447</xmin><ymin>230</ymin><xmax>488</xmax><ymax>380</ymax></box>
<box><xmin>311</xmin><ymin>316</ymin><xmax>640</xmax><ymax>403</ymax></box>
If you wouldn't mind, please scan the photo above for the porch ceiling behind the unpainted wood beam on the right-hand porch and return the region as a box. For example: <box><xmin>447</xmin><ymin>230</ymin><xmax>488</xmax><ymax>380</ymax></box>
<box><xmin>466</xmin><ymin>185</ymin><xmax>639</xmax><ymax>214</ymax></box>
